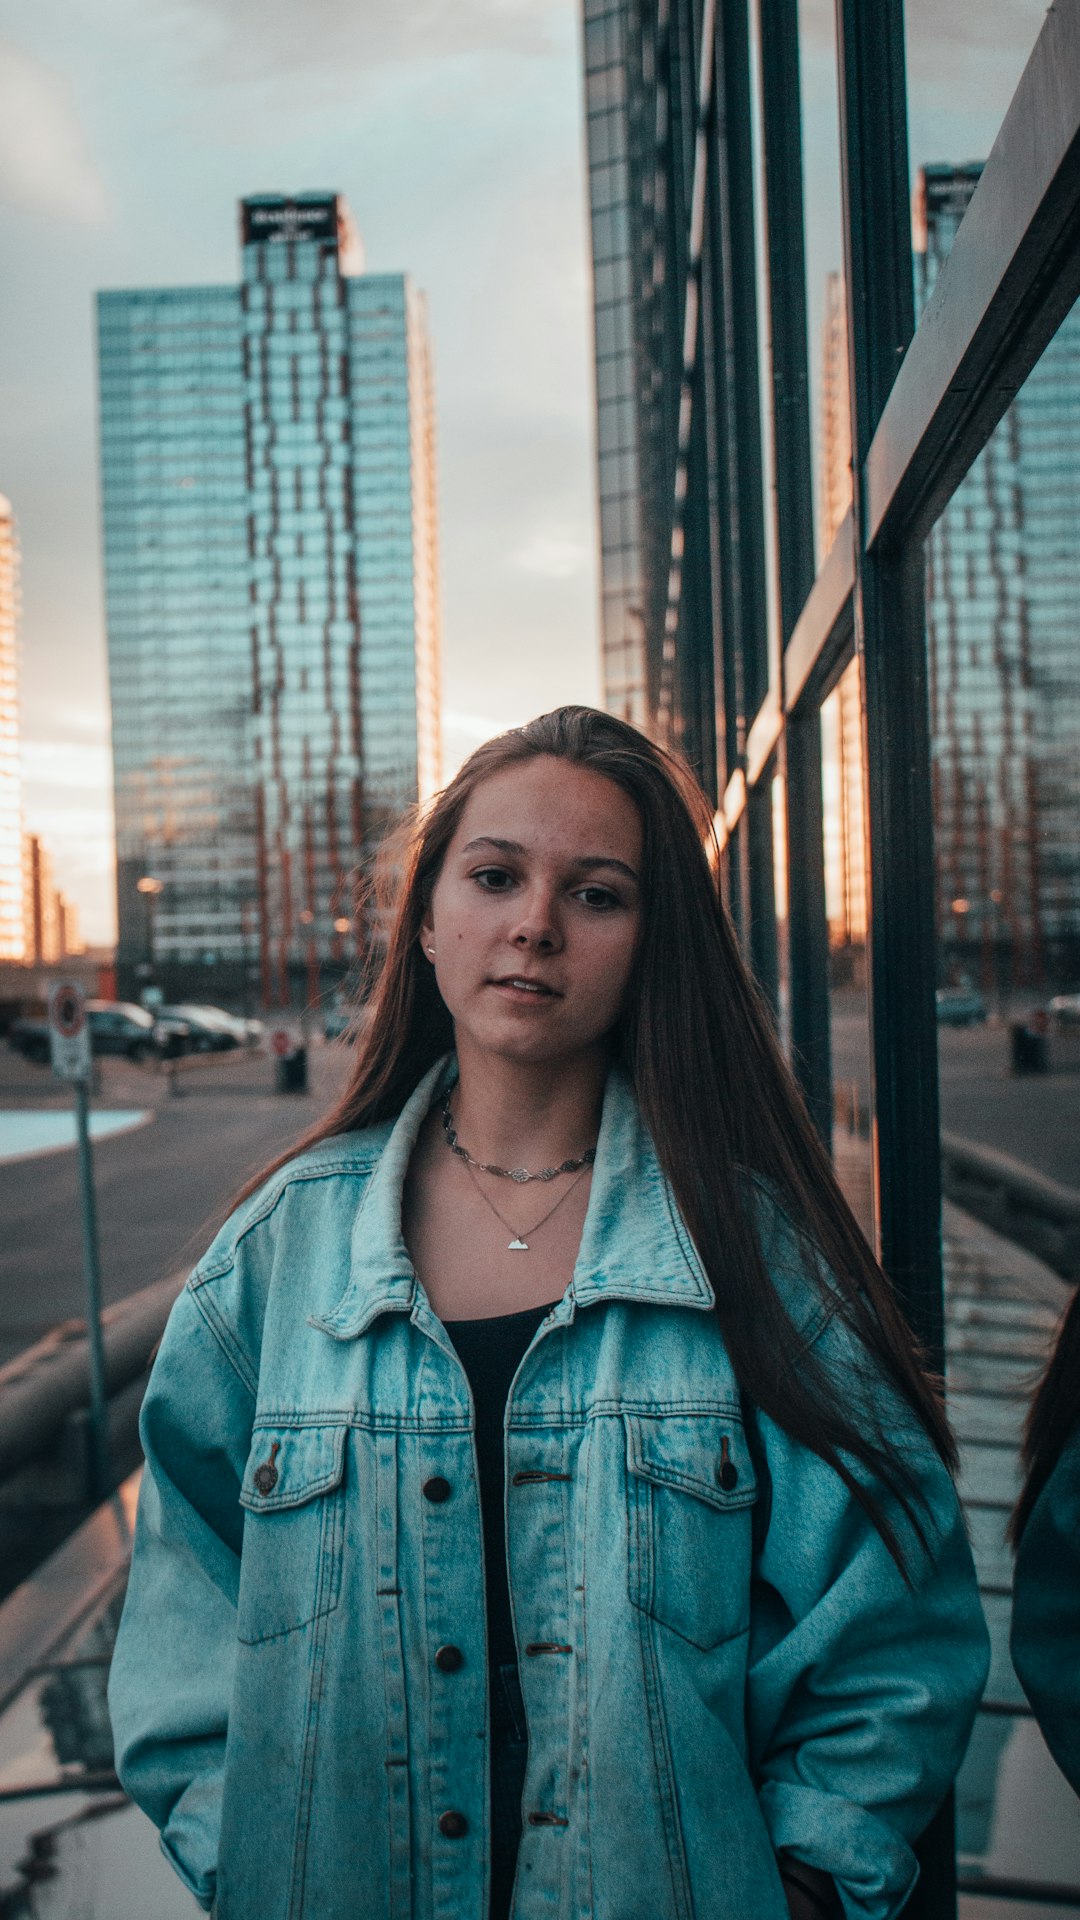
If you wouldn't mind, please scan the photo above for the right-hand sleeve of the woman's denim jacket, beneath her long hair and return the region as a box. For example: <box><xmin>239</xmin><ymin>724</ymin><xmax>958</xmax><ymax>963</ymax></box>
<box><xmin>748</xmin><ymin>1313</ymin><xmax>990</xmax><ymax>1920</ymax></box>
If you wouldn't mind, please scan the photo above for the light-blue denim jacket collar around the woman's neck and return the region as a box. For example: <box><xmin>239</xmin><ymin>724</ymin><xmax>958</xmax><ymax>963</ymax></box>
<box><xmin>311</xmin><ymin>1054</ymin><xmax>715</xmax><ymax>1340</ymax></box>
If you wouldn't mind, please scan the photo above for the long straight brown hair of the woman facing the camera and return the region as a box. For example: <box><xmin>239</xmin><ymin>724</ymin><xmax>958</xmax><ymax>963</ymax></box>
<box><xmin>249</xmin><ymin>707</ymin><xmax>955</xmax><ymax>1569</ymax></box>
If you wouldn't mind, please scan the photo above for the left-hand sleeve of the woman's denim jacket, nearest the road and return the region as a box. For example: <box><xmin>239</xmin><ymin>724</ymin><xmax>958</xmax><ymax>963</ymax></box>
<box><xmin>110</xmin><ymin>1283</ymin><xmax>254</xmax><ymax>1908</ymax></box>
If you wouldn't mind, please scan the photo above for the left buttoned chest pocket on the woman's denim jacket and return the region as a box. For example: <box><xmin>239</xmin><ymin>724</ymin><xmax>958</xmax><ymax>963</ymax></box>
<box><xmin>236</xmin><ymin>1421</ymin><xmax>350</xmax><ymax>1645</ymax></box>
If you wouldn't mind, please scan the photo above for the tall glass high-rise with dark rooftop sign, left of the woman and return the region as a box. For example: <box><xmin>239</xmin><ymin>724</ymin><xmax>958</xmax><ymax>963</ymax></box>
<box><xmin>98</xmin><ymin>194</ymin><xmax>440</xmax><ymax>1004</ymax></box>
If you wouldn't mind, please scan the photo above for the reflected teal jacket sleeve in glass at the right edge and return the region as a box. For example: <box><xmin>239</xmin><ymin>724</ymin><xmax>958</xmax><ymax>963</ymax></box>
<box><xmin>1011</xmin><ymin>1432</ymin><xmax>1080</xmax><ymax>1793</ymax></box>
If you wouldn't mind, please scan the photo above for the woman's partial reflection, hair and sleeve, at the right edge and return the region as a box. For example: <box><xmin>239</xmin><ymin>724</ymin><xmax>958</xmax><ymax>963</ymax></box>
<box><xmin>1011</xmin><ymin>1294</ymin><xmax>1080</xmax><ymax>1793</ymax></box>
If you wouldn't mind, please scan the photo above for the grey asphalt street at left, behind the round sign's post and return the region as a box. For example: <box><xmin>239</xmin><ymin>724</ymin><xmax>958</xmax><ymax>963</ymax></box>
<box><xmin>0</xmin><ymin>1043</ymin><xmax>350</xmax><ymax>1365</ymax></box>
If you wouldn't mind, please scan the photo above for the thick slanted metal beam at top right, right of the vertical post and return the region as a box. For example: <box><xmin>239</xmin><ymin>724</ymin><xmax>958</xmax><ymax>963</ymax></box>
<box><xmin>863</xmin><ymin>0</ymin><xmax>1080</xmax><ymax>545</ymax></box>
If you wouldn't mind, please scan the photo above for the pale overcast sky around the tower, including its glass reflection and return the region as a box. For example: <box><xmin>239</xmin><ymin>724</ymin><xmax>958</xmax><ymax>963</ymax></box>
<box><xmin>0</xmin><ymin>0</ymin><xmax>1045</xmax><ymax>939</ymax></box>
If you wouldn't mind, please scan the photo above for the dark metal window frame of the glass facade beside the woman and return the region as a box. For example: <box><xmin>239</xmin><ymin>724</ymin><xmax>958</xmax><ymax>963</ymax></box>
<box><xmin>586</xmin><ymin>0</ymin><xmax>1080</xmax><ymax>1920</ymax></box>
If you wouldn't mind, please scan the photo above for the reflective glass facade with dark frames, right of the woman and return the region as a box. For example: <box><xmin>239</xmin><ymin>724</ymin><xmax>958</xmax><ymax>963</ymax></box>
<box><xmin>584</xmin><ymin>0</ymin><xmax>1080</xmax><ymax>1920</ymax></box>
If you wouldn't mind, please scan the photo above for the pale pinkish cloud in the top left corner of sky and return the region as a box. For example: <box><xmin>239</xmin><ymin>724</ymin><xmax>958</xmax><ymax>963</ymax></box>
<box><xmin>0</xmin><ymin>40</ymin><xmax>108</xmax><ymax>227</ymax></box>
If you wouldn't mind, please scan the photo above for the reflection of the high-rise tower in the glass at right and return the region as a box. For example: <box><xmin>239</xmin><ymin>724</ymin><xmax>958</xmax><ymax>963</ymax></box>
<box><xmin>915</xmin><ymin>165</ymin><xmax>1080</xmax><ymax>995</ymax></box>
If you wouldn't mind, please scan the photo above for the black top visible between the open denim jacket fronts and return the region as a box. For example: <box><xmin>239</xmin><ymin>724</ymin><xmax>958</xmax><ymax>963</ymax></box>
<box><xmin>446</xmin><ymin>1300</ymin><xmax>555</xmax><ymax>1667</ymax></box>
